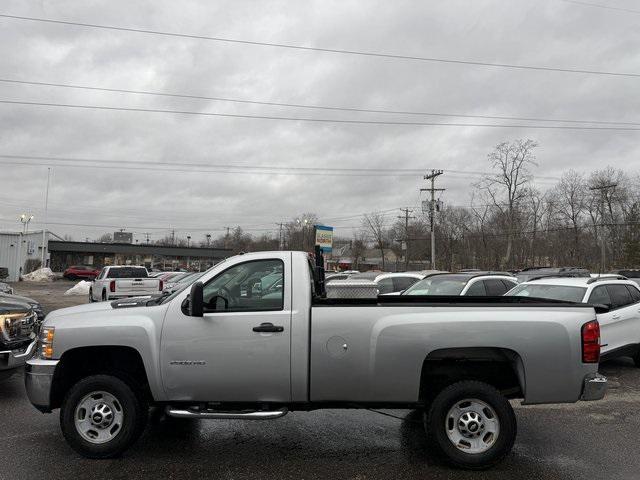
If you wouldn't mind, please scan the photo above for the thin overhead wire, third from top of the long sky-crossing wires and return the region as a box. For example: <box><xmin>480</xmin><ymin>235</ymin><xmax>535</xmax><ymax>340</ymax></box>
<box><xmin>0</xmin><ymin>100</ymin><xmax>640</xmax><ymax>131</ymax></box>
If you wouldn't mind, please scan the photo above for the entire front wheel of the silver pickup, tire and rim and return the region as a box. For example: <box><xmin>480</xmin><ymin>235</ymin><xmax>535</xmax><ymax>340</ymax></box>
<box><xmin>60</xmin><ymin>375</ymin><xmax>148</xmax><ymax>458</ymax></box>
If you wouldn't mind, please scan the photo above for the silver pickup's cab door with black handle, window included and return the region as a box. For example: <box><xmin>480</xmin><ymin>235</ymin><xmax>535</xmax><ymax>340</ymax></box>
<box><xmin>160</xmin><ymin>253</ymin><xmax>291</xmax><ymax>402</ymax></box>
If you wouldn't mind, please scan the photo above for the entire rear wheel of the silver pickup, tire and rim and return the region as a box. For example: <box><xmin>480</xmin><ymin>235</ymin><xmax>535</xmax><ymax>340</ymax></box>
<box><xmin>425</xmin><ymin>380</ymin><xmax>517</xmax><ymax>470</ymax></box>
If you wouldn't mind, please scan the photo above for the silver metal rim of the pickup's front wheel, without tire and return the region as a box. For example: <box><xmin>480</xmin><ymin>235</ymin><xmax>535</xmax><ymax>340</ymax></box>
<box><xmin>74</xmin><ymin>391</ymin><xmax>124</xmax><ymax>444</ymax></box>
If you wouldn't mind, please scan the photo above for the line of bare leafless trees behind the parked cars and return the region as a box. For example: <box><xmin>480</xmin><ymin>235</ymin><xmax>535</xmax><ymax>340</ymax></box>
<box><xmin>91</xmin><ymin>139</ymin><xmax>640</xmax><ymax>271</ymax></box>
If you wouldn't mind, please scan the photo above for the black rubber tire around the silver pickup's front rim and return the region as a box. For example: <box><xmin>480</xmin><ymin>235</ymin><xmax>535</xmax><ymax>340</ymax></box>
<box><xmin>60</xmin><ymin>375</ymin><xmax>148</xmax><ymax>458</ymax></box>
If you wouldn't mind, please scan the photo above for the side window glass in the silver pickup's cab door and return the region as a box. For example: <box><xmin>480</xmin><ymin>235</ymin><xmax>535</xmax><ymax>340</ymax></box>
<box><xmin>203</xmin><ymin>260</ymin><xmax>284</xmax><ymax>312</ymax></box>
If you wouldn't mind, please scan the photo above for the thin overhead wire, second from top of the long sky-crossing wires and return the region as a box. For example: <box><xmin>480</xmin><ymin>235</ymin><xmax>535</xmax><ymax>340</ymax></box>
<box><xmin>0</xmin><ymin>78</ymin><xmax>640</xmax><ymax>126</ymax></box>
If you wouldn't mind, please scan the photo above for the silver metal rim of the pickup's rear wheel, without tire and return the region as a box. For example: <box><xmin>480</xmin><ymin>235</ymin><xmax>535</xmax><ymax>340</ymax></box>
<box><xmin>445</xmin><ymin>398</ymin><xmax>500</xmax><ymax>454</ymax></box>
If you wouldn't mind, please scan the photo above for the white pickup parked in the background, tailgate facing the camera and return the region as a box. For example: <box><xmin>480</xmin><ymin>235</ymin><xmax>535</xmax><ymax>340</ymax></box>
<box><xmin>89</xmin><ymin>265</ymin><xmax>164</xmax><ymax>302</ymax></box>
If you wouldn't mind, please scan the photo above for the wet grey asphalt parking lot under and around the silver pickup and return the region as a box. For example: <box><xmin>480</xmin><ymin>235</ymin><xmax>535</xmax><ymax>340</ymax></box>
<box><xmin>0</xmin><ymin>281</ymin><xmax>640</xmax><ymax>480</ymax></box>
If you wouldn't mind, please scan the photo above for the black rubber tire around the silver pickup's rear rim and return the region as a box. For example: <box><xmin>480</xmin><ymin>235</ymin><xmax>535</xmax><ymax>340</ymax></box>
<box><xmin>425</xmin><ymin>380</ymin><xmax>517</xmax><ymax>470</ymax></box>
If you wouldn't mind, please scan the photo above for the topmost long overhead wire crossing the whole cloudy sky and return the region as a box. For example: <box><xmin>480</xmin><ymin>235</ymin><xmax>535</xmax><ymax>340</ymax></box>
<box><xmin>0</xmin><ymin>14</ymin><xmax>640</xmax><ymax>78</ymax></box>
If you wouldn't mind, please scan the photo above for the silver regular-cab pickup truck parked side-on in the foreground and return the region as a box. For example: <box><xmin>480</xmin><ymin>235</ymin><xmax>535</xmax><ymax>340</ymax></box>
<box><xmin>25</xmin><ymin>251</ymin><xmax>606</xmax><ymax>469</ymax></box>
